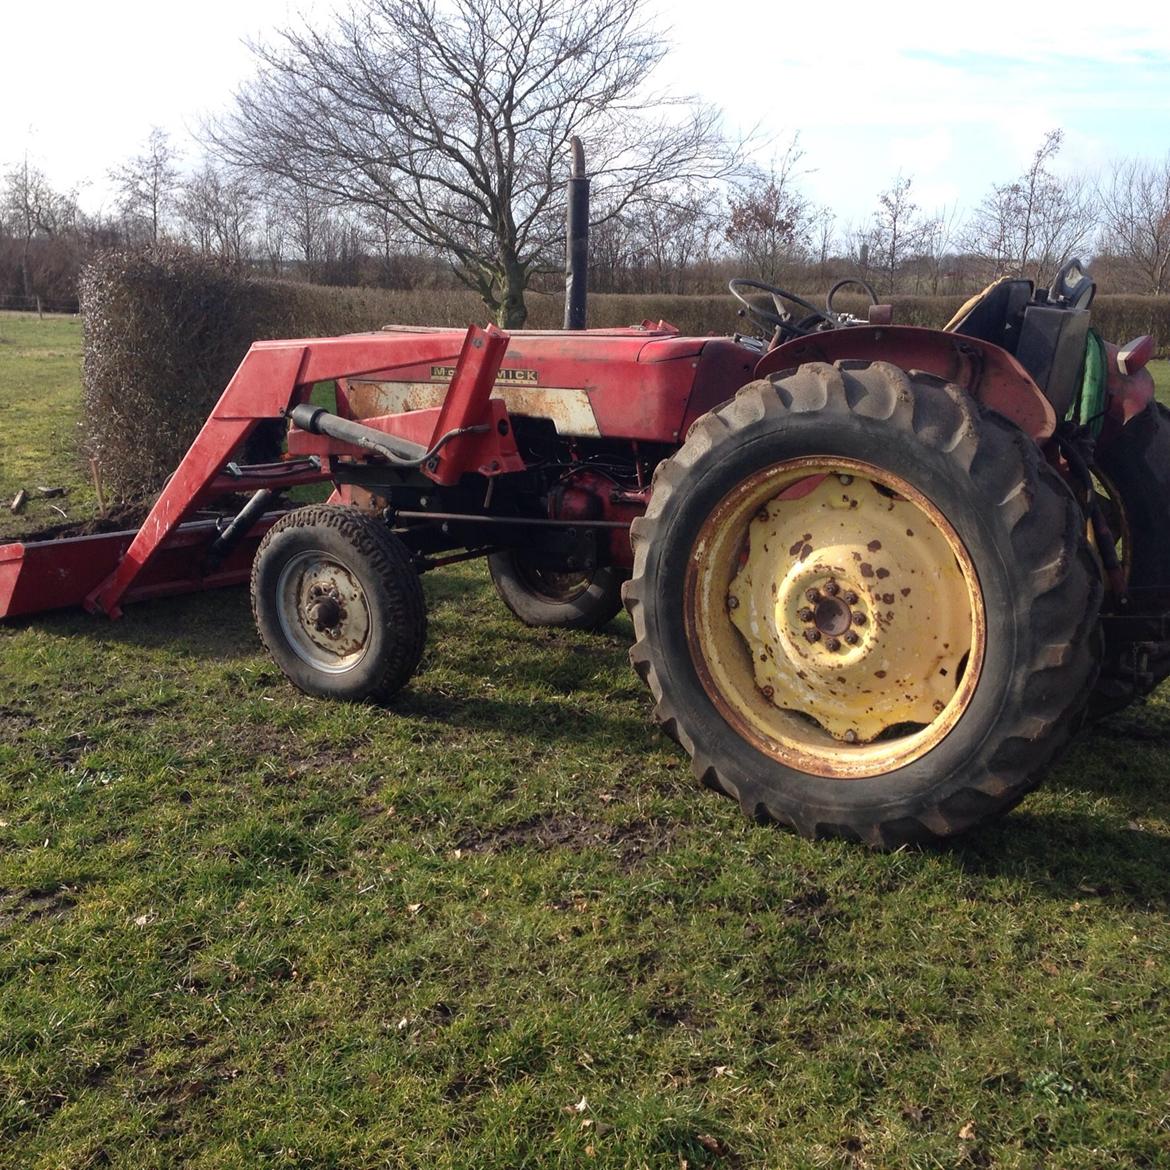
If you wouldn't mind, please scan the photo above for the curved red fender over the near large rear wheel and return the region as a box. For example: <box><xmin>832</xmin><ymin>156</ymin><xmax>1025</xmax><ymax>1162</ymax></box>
<box><xmin>756</xmin><ymin>325</ymin><xmax>1057</xmax><ymax>443</ymax></box>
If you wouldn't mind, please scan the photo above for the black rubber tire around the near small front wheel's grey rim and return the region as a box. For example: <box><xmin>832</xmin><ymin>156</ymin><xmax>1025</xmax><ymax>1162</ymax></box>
<box><xmin>252</xmin><ymin>504</ymin><xmax>427</xmax><ymax>702</ymax></box>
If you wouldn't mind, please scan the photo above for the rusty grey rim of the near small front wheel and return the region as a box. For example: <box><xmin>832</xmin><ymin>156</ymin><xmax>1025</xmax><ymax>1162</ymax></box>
<box><xmin>276</xmin><ymin>552</ymin><xmax>371</xmax><ymax>674</ymax></box>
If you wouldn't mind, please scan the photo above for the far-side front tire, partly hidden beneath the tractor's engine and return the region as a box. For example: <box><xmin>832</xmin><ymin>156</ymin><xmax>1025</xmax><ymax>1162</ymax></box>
<box><xmin>488</xmin><ymin>550</ymin><xmax>626</xmax><ymax>629</ymax></box>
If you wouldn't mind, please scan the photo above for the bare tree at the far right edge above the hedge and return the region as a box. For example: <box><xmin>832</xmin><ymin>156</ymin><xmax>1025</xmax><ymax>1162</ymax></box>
<box><xmin>1100</xmin><ymin>154</ymin><xmax>1170</xmax><ymax>294</ymax></box>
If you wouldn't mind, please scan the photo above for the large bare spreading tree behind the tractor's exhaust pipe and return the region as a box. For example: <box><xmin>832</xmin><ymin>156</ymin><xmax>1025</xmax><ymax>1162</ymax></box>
<box><xmin>209</xmin><ymin>0</ymin><xmax>738</xmax><ymax>326</ymax></box>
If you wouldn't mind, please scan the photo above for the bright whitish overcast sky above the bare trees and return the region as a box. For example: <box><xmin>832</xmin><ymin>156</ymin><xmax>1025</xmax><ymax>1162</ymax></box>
<box><xmin>0</xmin><ymin>0</ymin><xmax>1170</xmax><ymax>222</ymax></box>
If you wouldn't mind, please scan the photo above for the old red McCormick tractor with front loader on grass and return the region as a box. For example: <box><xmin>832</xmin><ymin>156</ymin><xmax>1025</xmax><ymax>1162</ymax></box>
<box><xmin>0</xmin><ymin>262</ymin><xmax>1170</xmax><ymax>847</ymax></box>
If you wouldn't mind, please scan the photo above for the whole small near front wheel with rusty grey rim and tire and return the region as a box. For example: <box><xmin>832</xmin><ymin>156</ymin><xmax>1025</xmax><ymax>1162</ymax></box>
<box><xmin>252</xmin><ymin>504</ymin><xmax>427</xmax><ymax>702</ymax></box>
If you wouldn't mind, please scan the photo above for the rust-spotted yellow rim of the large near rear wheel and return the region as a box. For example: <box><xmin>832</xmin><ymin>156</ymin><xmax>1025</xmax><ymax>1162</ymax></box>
<box><xmin>684</xmin><ymin>457</ymin><xmax>986</xmax><ymax>778</ymax></box>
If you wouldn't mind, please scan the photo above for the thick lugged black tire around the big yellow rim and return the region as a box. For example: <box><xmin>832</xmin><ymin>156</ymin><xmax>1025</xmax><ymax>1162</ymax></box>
<box><xmin>624</xmin><ymin>362</ymin><xmax>1101</xmax><ymax>848</ymax></box>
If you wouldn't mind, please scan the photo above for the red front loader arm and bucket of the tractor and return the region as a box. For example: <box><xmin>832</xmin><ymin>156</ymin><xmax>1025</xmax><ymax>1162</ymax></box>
<box><xmin>0</xmin><ymin>325</ymin><xmax>512</xmax><ymax>618</ymax></box>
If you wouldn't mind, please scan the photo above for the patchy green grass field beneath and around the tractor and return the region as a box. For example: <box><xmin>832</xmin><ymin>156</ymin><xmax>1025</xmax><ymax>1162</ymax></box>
<box><xmin>0</xmin><ymin>317</ymin><xmax>1170</xmax><ymax>1170</ymax></box>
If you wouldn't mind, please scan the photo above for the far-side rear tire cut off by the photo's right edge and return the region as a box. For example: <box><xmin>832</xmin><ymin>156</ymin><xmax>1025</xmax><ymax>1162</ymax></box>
<box><xmin>1092</xmin><ymin>402</ymin><xmax>1170</xmax><ymax>717</ymax></box>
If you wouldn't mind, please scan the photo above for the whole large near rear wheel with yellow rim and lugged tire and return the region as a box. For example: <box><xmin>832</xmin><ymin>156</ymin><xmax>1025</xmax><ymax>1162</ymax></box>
<box><xmin>625</xmin><ymin>362</ymin><xmax>1101</xmax><ymax>848</ymax></box>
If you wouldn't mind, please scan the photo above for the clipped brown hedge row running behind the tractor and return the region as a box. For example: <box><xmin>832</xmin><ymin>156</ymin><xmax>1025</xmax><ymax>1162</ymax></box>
<box><xmin>81</xmin><ymin>247</ymin><xmax>1170</xmax><ymax>500</ymax></box>
